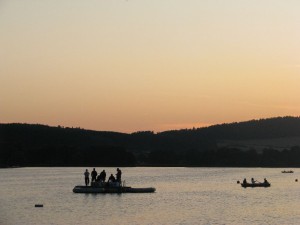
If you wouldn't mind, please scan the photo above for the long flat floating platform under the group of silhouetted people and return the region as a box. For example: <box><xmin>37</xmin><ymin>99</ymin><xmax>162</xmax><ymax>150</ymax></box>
<box><xmin>73</xmin><ymin>182</ymin><xmax>156</xmax><ymax>194</ymax></box>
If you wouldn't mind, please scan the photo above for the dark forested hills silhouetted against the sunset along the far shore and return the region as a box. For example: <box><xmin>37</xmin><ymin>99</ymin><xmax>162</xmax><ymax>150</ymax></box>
<box><xmin>0</xmin><ymin>117</ymin><xmax>300</xmax><ymax>167</ymax></box>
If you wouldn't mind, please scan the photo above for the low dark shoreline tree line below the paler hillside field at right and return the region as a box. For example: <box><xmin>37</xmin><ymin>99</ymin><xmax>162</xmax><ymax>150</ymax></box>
<box><xmin>140</xmin><ymin>146</ymin><xmax>300</xmax><ymax>167</ymax></box>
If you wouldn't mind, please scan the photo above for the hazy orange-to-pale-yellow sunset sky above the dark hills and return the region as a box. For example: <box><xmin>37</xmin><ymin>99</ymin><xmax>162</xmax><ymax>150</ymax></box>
<box><xmin>0</xmin><ymin>0</ymin><xmax>300</xmax><ymax>133</ymax></box>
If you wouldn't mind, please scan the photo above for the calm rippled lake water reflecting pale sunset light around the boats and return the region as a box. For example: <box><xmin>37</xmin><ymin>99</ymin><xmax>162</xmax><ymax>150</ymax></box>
<box><xmin>0</xmin><ymin>167</ymin><xmax>300</xmax><ymax>225</ymax></box>
